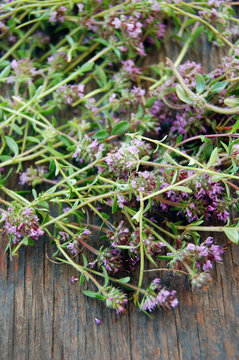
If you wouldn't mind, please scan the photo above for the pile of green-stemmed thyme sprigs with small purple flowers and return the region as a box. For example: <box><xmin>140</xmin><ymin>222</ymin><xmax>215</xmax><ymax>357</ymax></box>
<box><xmin>0</xmin><ymin>0</ymin><xmax>239</xmax><ymax>314</ymax></box>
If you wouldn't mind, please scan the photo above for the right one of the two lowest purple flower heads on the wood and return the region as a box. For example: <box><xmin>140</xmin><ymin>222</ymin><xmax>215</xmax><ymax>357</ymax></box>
<box><xmin>141</xmin><ymin>278</ymin><xmax>178</xmax><ymax>312</ymax></box>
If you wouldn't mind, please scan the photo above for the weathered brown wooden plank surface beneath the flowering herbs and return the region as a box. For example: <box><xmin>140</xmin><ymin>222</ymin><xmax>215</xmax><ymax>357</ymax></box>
<box><xmin>0</xmin><ymin>35</ymin><xmax>239</xmax><ymax>360</ymax></box>
